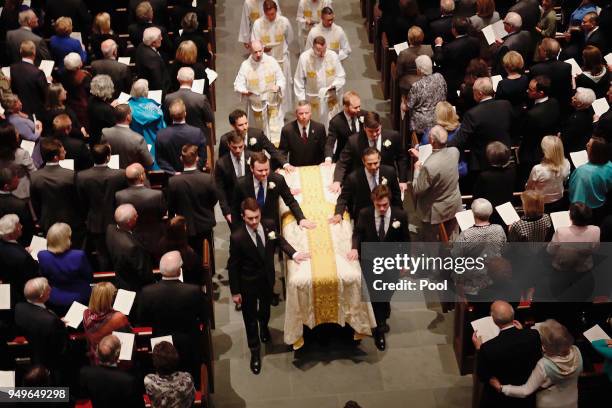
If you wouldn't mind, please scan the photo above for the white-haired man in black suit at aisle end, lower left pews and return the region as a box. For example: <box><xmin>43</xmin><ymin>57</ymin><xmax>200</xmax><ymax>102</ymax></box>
<box><xmin>138</xmin><ymin>251</ymin><xmax>210</xmax><ymax>384</ymax></box>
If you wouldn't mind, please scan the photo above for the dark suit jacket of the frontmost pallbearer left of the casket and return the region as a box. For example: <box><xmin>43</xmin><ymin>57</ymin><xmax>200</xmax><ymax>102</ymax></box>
<box><xmin>227</xmin><ymin>220</ymin><xmax>296</xmax><ymax>295</ymax></box>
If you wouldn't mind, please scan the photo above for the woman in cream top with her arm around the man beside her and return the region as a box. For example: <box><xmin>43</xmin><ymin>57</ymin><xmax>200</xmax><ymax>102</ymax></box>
<box><xmin>489</xmin><ymin>319</ymin><xmax>582</xmax><ymax>408</ymax></box>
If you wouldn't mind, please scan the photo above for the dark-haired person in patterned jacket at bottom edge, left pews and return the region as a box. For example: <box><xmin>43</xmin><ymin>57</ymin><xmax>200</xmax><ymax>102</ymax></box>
<box><xmin>144</xmin><ymin>341</ymin><xmax>195</xmax><ymax>408</ymax></box>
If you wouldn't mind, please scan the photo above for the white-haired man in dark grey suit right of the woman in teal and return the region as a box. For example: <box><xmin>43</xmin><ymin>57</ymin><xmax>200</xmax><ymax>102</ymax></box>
<box><xmin>164</xmin><ymin>67</ymin><xmax>215</xmax><ymax>140</ymax></box>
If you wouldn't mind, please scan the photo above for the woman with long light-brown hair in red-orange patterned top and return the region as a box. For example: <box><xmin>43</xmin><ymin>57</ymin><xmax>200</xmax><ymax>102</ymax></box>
<box><xmin>83</xmin><ymin>282</ymin><xmax>132</xmax><ymax>365</ymax></box>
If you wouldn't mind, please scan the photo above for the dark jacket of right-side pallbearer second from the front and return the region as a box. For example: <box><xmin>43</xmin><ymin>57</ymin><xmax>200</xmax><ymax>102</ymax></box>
<box><xmin>334</xmin><ymin>165</ymin><xmax>402</xmax><ymax>220</ymax></box>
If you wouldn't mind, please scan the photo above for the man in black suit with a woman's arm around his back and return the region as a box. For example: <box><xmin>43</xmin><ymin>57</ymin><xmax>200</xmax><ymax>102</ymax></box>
<box><xmin>472</xmin><ymin>300</ymin><xmax>542</xmax><ymax>408</ymax></box>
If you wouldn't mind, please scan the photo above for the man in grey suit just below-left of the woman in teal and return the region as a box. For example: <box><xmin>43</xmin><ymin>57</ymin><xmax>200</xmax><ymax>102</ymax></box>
<box><xmin>101</xmin><ymin>104</ymin><xmax>153</xmax><ymax>169</ymax></box>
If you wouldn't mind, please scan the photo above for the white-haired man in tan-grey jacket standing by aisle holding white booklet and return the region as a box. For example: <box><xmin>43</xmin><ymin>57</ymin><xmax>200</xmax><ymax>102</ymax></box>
<box><xmin>410</xmin><ymin>125</ymin><xmax>461</xmax><ymax>242</ymax></box>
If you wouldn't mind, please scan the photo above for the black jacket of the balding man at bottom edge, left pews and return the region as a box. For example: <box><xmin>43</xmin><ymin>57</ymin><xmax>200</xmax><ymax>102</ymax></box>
<box><xmin>79</xmin><ymin>366</ymin><xmax>145</xmax><ymax>408</ymax></box>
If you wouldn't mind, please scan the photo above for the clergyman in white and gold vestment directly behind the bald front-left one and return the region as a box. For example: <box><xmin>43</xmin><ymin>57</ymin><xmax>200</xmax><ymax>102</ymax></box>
<box><xmin>251</xmin><ymin>0</ymin><xmax>293</xmax><ymax>112</ymax></box>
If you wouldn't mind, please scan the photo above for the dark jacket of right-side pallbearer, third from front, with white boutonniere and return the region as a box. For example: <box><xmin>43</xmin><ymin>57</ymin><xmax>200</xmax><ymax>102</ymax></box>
<box><xmin>334</xmin><ymin>129</ymin><xmax>408</xmax><ymax>182</ymax></box>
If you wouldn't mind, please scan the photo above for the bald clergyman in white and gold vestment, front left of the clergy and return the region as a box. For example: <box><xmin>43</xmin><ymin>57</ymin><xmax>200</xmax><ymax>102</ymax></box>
<box><xmin>234</xmin><ymin>41</ymin><xmax>286</xmax><ymax>143</ymax></box>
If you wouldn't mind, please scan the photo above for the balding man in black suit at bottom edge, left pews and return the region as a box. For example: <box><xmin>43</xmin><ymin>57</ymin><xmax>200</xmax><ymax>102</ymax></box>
<box><xmin>79</xmin><ymin>334</ymin><xmax>145</xmax><ymax>408</ymax></box>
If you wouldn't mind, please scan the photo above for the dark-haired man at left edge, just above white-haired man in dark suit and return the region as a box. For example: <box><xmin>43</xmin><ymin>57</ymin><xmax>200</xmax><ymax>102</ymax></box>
<box><xmin>0</xmin><ymin>167</ymin><xmax>34</xmax><ymax>246</ymax></box>
